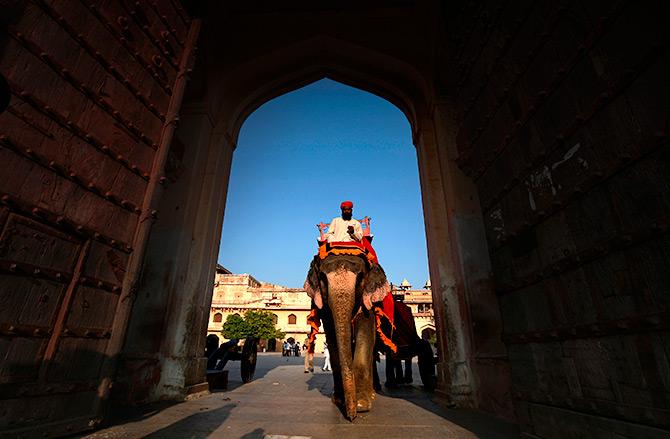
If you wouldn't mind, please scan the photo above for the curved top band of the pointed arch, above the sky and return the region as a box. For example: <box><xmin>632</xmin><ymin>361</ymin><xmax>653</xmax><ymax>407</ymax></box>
<box><xmin>215</xmin><ymin>35</ymin><xmax>431</xmax><ymax>144</ymax></box>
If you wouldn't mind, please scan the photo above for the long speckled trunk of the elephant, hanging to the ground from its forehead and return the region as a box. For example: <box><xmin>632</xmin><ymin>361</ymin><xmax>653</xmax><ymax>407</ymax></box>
<box><xmin>327</xmin><ymin>267</ymin><xmax>356</xmax><ymax>420</ymax></box>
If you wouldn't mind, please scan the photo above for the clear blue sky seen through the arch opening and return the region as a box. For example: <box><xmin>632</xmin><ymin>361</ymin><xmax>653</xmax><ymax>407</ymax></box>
<box><xmin>219</xmin><ymin>79</ymin><xmax>428</xmax><ymax>288</ymax></box>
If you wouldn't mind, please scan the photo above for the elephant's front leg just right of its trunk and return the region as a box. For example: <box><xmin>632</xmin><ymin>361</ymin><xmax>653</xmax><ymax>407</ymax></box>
<box><xmin>353</xmin><ymin>313</ymin><xmax>375</xmax><ymax>412</ymax></box>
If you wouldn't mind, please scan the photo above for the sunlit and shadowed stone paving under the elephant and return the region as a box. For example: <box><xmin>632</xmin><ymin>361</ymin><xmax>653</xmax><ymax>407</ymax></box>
<box><xmin>81</xmin><ymin>353</ymin><xmax>518</xmax><ymax>439</ymax></box>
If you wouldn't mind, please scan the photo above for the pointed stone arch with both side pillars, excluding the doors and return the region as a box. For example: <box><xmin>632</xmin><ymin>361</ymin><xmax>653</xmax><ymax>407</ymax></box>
<box><xmin>119</xmin><ymin>15</ymin><xmax>512</xmax><ymax>417</ymax></box>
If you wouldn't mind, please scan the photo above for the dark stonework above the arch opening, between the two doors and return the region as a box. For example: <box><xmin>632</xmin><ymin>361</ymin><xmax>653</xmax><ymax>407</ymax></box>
<box><xmin>193</xmin><ymin>2</ymin><xmax>438</xmax><ymax>147</ymax></box>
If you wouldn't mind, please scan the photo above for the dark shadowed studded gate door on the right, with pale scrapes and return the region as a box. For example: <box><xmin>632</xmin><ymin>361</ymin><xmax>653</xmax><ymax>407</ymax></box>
<box><xmin>438</xmin><ymin>1</ymin><xmax>670</xmax><ymax>438</ymax></box>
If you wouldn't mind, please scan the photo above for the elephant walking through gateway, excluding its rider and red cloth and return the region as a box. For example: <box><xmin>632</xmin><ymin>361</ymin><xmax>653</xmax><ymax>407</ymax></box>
<box><xmin>305</xmin><ymin>254</ymin><xmax>390</xmax><ymax>421</ymax></box>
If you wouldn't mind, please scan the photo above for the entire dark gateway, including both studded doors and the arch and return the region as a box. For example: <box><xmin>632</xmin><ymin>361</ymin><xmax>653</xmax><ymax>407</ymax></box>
<box><xmin>0</xmin><ymin>0</ymin><xmax>670</xmax><ymax>437</ymax></box>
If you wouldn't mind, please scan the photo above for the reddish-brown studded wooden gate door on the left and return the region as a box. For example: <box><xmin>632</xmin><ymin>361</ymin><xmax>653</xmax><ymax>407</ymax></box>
<box><xmin>0</xmin><ymin>0</ymin><xmax>199</xmax><ymax>437</ymax></box>
